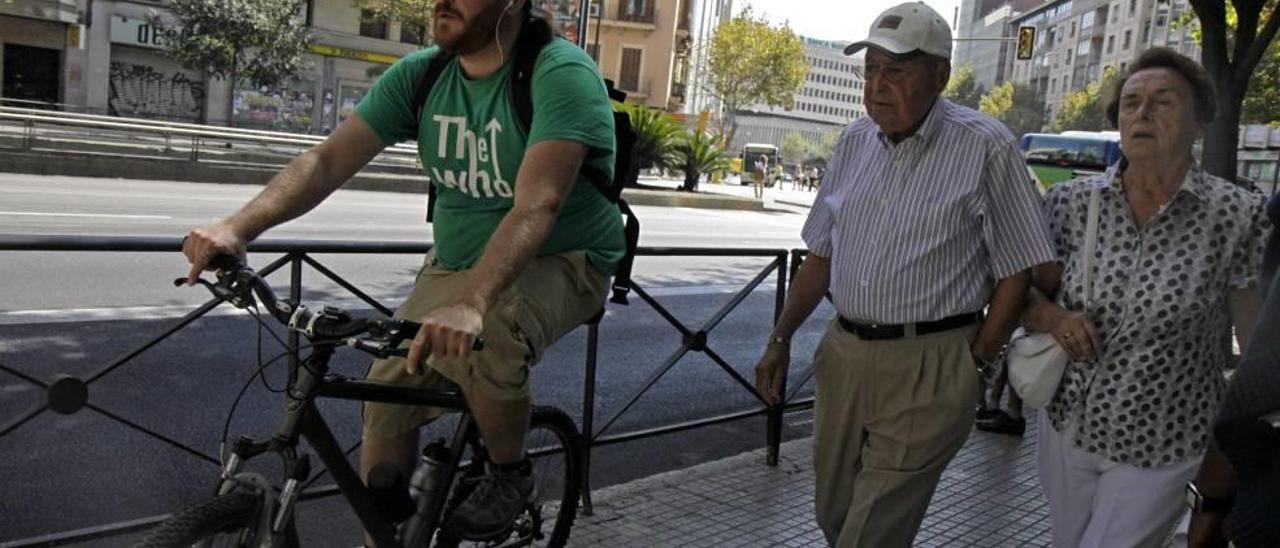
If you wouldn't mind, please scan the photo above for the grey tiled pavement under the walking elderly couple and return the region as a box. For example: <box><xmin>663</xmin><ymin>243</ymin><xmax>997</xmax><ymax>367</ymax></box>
<box><xmin>570</xmin><ymin>412</ymin><xmax>1048</xmax><ymax>547</ymax></box>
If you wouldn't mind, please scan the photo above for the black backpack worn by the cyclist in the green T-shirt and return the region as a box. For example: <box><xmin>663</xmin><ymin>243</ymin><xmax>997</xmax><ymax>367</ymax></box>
<box><xmin>413</xmin><ymin>24</ymin><xmax>640</xmax><ymax>305</ymax></box>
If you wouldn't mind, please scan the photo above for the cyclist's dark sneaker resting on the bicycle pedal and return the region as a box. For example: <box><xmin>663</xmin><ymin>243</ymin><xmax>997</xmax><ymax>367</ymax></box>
<box><xmin>449</xmin><ymin>458</ymin><xmax>534</xmax><ymax>542</ymax></box>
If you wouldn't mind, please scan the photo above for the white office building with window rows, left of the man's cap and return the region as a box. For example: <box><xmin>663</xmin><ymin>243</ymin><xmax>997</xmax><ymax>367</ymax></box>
<box><xmin>730</xmin><ymin>38</ymin><xmax>867</xmax><ymax>151</ymax></box>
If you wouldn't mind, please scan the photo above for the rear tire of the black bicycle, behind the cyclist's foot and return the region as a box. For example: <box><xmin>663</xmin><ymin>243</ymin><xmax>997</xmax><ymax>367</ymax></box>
<box><xmin>434</xmin><ymin>406</ymin><xmax>584</xmax><ymax>548</ymax></box>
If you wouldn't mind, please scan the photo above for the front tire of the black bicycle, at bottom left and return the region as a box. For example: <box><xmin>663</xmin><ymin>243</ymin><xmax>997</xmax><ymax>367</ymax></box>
<box><xmin>134</xmin><ymin>493</ymin><xmax>298</xmax><ymax>548</ymax></box>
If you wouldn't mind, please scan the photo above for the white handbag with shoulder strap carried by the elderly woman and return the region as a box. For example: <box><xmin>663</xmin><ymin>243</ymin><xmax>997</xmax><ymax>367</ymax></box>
<box><xmin>1006</xmin><ymin>183</ymin><xmax>1111</xmax><ymax>408</ymax></box>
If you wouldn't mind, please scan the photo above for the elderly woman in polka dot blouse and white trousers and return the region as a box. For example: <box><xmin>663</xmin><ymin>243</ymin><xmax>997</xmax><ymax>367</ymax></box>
<box><xmin>1023</xmin><ymin>49</ymin><xmax>1270</xmax><ymax>547</ymax></box>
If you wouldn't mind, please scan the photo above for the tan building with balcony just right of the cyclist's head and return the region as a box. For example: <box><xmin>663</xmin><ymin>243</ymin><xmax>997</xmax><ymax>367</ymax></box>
<box><xmin>586</xmin><ymin>0</ymin><xmax>692</xmax><ymax>113</ymax></box>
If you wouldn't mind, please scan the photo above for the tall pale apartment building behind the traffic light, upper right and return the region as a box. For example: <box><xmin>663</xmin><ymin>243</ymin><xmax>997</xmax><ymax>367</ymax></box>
<box><xmin>1011</xmin><ymin>0</ymin><xmax>1199</xmax><ymax>119</ymax></box>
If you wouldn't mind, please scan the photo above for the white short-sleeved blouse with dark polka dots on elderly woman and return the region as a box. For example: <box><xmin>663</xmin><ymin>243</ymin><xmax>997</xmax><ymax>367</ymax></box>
<box><xmin>1043</xmin><ymin>168</ymin><xmax>1271</xmax><ymax>467</ymax></box>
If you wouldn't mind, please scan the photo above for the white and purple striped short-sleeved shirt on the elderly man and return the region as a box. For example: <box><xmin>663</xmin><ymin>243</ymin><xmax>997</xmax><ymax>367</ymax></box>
<box><xmin>801</xmin><ymin>99</ymin><xmax>1055</xmax><ymax>324</ymax></box>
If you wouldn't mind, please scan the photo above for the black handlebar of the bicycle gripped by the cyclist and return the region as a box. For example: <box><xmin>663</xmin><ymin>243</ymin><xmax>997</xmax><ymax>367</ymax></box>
<box><xmin>174</xmin><ymin>255</ymin><xmax>484</xmax><ymax>359</ymax></box>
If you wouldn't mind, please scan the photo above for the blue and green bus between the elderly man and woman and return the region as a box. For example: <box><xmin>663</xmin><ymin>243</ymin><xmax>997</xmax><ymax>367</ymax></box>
<box><xmin>1019</xmin><ymin>132</ymin><xmax>1120</xmax><ymax>188</ymax></box>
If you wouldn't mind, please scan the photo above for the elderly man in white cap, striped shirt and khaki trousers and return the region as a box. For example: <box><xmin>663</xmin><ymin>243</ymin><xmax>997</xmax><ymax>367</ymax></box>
<box><xmin>756</xmin><ymin>3</ymin><xmax>1053</xmax><ymax>548</ymax></box>
